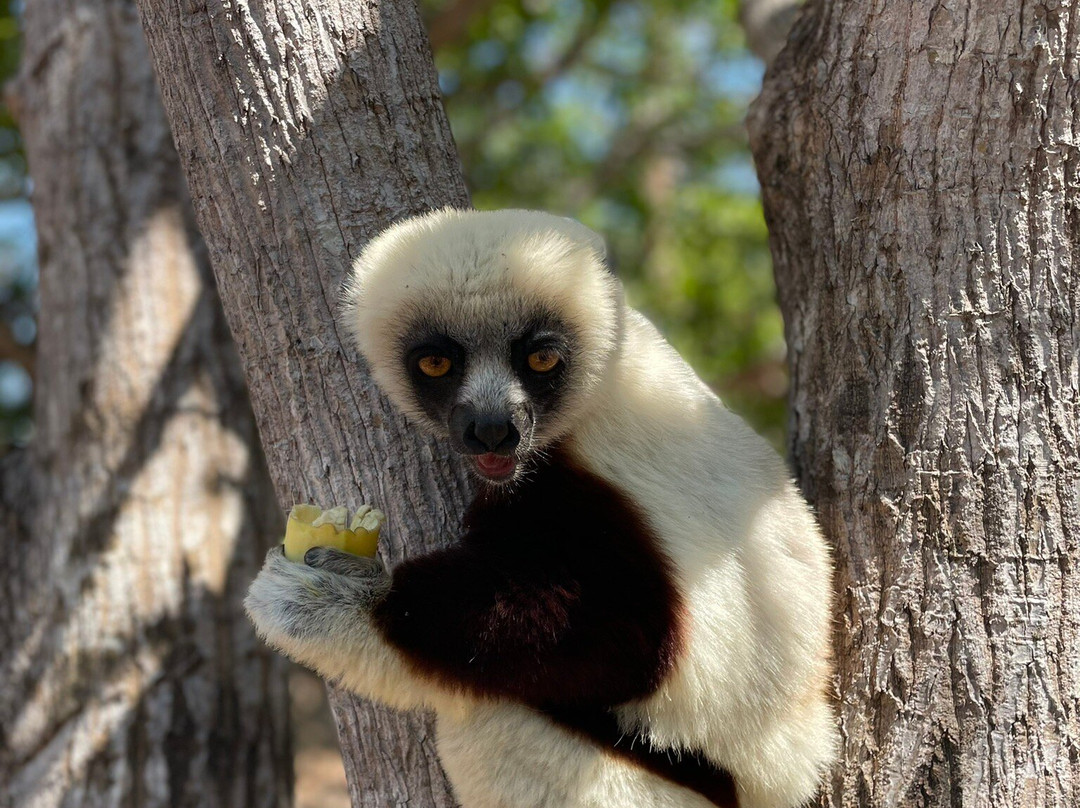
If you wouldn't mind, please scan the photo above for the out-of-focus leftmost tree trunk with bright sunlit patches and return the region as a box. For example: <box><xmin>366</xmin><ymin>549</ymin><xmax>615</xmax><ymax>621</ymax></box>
<box><xmin>0</xmin><ymin>0</ymin><xmax>292</xmax><ymax>808</ymax></box>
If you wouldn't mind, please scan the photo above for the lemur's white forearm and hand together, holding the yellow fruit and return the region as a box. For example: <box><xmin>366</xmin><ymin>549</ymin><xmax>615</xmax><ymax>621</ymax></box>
<box><xmin>244</xmin><ymin>547</ymin><xmax>462</xmax><ymax>710</ymax></box>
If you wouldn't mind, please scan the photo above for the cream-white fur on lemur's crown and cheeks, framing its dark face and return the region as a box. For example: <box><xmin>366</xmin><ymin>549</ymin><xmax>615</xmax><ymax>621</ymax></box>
<box><xmin>342</xmin><ymin>208</ymin><xmax>624</xmax><ymax>470</ymax></box>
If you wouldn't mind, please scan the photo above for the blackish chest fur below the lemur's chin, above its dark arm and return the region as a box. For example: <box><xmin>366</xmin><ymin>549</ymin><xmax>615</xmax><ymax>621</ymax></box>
<box><xmin>462</xmin><ymin>450</ymin><xmax>683</xmax><ymax>684</ymax></box>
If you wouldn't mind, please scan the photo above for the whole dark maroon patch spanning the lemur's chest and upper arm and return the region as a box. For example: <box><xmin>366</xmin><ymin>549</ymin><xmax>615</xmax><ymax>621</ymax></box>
<box><xmin>379</xmin><ymin>452</ymin><xmax>683</xmax><ymax>709</ymax></box>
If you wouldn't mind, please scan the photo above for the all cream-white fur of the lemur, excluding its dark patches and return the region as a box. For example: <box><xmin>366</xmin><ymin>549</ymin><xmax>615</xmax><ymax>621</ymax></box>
<box><xmin>246</xmin><ymin>210</ymin><xmax>837</xmax><ymax>808</ymax></box>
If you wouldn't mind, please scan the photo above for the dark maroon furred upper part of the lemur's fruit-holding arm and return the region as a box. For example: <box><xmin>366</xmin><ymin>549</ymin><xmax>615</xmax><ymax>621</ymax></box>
<box><xmin>374</xmin><ymin>547</ymin><xmax>674</xmax><ymax>708</ymax></box>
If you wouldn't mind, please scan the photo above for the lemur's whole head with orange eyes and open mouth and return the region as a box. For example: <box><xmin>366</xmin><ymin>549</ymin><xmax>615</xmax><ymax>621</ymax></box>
<box><xmin>343</xmin><ymin>210</ymin><xmax>623</xmax><ymax>484</ymax></box>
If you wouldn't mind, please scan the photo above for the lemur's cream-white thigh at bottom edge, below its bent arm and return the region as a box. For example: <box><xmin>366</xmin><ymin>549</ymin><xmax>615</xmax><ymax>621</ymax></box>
<box><xmin>437</xmin><ymin>701</ymin><xmax>716</xmax><ymax>808</ymax></box>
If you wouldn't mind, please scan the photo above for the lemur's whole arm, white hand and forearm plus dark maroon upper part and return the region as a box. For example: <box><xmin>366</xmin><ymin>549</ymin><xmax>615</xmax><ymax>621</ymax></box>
<box><xmin>245</xmin><ymin>533</ymin><xmax>674</xmax><ymax>709</ymax></box>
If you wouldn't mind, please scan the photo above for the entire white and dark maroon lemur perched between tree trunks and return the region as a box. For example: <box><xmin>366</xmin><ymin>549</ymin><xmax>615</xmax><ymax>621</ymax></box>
<box><xmin>246</xmin><ymin>210</ymin><xmax>837</xmax><ymax>808</ymax></box>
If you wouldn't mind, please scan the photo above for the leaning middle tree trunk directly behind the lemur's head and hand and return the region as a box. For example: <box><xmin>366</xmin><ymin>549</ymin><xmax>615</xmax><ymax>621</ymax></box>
<box><xmin>132</xmin><ymin>0</ymin><xmax>468</xmax><ymax>808</ymax></box>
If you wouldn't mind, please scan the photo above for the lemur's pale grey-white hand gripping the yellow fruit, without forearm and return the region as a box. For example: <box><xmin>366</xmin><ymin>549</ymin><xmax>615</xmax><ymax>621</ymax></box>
<box><xmin>244</xmin><ymin>546</ymin><xmax>390</xmax><ymax>664</ymax></box>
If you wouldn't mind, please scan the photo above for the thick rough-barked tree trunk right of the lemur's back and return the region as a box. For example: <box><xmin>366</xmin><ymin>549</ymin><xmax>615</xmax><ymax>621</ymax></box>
<box><xmin>752</xmin><ymin>0</ymin><xmax>1080</xmax><ymax>808</ymax></box>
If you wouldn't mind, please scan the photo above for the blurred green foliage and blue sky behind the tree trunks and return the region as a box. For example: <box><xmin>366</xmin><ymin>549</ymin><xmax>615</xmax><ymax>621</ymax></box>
<box><xmin>0</xmin><ymin>0</ymin><xmax>786</xmax><ymax>453</ymax></box>
